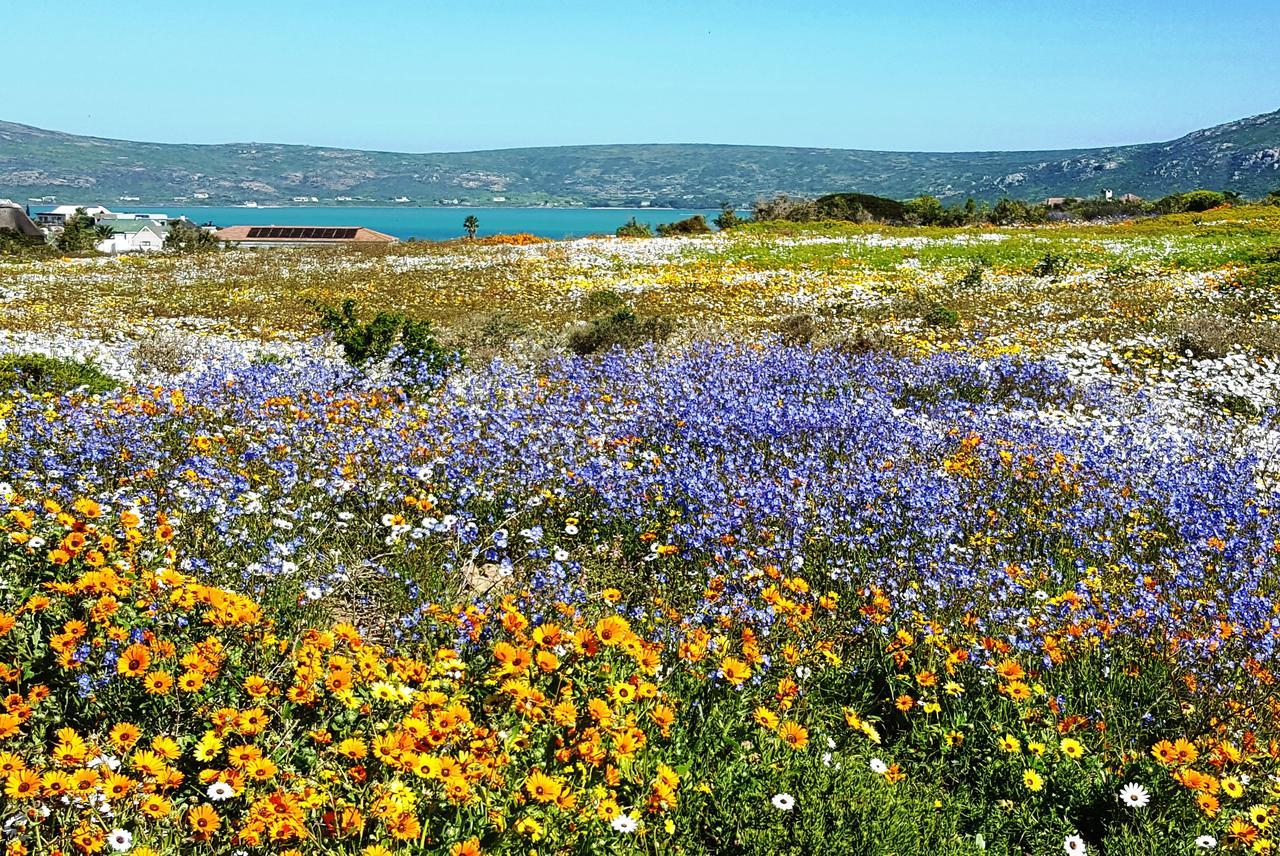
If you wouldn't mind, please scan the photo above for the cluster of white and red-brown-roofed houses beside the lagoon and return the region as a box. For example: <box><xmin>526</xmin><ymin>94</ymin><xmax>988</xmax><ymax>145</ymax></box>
<box><xmin>0</xmin><ymin>200</ymin><xmax>398</xmax><ymax>256</ymax></box>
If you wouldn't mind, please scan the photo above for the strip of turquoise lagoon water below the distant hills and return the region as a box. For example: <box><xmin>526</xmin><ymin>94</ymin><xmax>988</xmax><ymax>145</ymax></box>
<box><xmin>87</xmin><ymin>205</ymin><xmax>719</xmax><ymax>241</ymax></box>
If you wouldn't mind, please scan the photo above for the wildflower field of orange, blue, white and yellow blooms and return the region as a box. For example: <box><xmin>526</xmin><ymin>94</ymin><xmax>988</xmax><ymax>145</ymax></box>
<box><xmin>0</xmin><ymin>207</ymin><xmax>1280</xmax><ymax>856</ymax></box>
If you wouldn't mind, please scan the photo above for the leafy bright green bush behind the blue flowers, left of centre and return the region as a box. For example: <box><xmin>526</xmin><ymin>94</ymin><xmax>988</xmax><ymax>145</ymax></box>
<box><xmin>320</xmin><ymin>298</ymin><xmax>458</xmax><ymax>371</ymax></box>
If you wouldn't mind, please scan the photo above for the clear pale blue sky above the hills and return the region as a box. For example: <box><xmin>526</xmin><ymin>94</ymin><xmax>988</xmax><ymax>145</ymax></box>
<box><xmin>10</xmin><ymin>0</ymin><xmax>1280</xmax><ymax>151</ymax></box>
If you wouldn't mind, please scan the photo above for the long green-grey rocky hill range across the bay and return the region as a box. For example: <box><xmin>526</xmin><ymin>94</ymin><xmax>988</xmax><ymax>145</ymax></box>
<box><xmin>0</xmin><ymin>111</ymin><xmax>1280</xmax><ymax>207</ymax></box>
